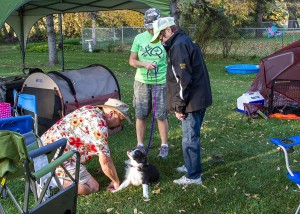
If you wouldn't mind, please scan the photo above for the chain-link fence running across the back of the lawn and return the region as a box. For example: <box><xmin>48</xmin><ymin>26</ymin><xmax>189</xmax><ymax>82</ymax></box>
<box><xmin>82</xmin><ymin>27</ymin><xmax>300</xmax><ymax>57</ymax></box>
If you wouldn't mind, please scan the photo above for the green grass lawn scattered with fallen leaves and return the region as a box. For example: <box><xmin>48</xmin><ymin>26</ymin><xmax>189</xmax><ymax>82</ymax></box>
<box><xmin>0</xmin><ymin>46</ymin><xmax>299</xmax><ymax>214</ymax></box>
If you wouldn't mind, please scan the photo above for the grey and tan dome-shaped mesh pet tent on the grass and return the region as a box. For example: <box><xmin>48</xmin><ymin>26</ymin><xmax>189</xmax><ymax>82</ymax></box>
<box><xmin>21</xmin><ymin>64</ymin><xmax>121</xmax><ymax>134</ymax></box>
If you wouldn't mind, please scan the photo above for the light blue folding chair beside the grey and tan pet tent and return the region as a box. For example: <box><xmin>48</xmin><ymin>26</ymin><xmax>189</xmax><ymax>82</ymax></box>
<box><xmin>14</xmin><ymin>90</ymin><xmax>38</xmax><ymax>135</ymax></box>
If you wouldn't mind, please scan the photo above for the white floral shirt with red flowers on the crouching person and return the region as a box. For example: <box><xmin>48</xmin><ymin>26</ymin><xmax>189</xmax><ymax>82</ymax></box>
<box><xmin>41</xmin><ymin>106</ymin><xmax>110</xmax><ymax>177</ymax></box>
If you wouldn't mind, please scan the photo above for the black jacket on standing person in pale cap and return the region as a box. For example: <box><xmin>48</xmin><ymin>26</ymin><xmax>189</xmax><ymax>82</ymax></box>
<box><xmin>164</xmin><ymin>30</ymin><xmax>212</xmax><ymax>113</ymax></box>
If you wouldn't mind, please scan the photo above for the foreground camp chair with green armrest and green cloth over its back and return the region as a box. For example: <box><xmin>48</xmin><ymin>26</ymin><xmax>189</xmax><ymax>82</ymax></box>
<box><xmin>0</xmin><ymin>131</ymin><xmax>80</xmax><ymax>214</ymax></box>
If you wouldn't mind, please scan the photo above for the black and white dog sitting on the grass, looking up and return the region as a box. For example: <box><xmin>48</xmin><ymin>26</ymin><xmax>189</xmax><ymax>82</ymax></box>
<box><xmin>113</xmin><ymin>149</ymin><xmax>159</xmax><ymax>200</ymax></box>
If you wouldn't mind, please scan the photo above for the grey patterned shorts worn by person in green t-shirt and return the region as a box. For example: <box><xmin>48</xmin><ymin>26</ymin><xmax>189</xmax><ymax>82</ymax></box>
<box><xmin>133</xmin><ymin>81</ymin><xmax>168</xmax><ymax>120</ymax></box>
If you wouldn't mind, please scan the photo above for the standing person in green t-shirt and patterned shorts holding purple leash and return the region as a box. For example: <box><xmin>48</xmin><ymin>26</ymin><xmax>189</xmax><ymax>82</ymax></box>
<box><xmin>129</xmin><ymin>8</ymin><xmax>169</xmax><ymax>158</ymax></box>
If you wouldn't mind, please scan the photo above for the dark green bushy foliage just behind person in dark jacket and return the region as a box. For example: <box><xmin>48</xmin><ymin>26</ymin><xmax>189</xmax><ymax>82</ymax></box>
<box><xmin>178</xmin><ymin>0</ymin><xmax>237</xmax><ymax>58</ymax></box>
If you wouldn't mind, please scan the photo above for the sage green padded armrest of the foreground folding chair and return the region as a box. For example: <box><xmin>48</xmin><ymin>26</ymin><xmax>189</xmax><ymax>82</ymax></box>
<box><xmin>32</xmin><ymin>150</ymin><xmax>80</xmax><ymax>179</ymax></box>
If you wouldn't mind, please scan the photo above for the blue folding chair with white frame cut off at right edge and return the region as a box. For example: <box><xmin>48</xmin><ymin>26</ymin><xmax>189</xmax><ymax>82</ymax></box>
<box><xmin>270</xmin><ymin>136</ymin><xmax>300</xmax><ymax>213</ymax></box>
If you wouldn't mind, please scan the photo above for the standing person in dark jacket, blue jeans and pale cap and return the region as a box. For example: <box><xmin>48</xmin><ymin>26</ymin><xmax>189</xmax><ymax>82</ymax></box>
<box><xmin>151</xmin><ymin>17</ymin><xmax>212</xmax><ymax>185</ymax></box>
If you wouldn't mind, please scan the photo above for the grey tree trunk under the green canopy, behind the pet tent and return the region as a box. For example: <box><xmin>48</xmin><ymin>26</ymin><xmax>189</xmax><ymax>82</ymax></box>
<box><xmin>46</xmin><ymin>15</ymin><xmax>58</xmax><ymax>66</ymax></box>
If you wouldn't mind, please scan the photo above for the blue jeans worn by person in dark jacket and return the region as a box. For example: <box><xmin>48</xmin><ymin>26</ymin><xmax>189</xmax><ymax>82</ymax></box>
<box><xmin>182</xmin><ymin>108</ymin><xmax>206</xmax><ymax>179</ymax></box>
